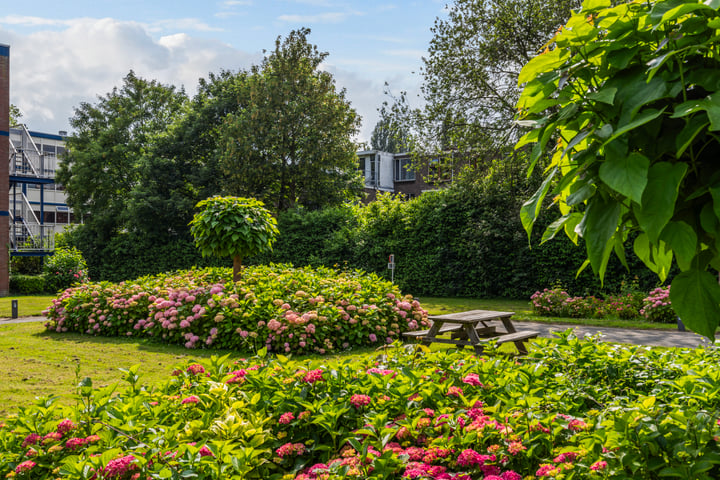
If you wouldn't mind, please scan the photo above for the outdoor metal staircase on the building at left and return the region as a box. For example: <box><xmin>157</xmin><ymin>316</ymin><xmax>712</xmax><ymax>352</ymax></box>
<box><xmin>10</xmin><ymin>125</ymin><xmax>57</xmax><ymax>256</ymax></box>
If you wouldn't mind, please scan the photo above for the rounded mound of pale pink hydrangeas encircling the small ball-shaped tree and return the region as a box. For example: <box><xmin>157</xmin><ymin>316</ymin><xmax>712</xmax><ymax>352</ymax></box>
<box><xmin>44</xmin><ymin>265</ymin><xmax>427</xmax><ymax>354</ymax></box>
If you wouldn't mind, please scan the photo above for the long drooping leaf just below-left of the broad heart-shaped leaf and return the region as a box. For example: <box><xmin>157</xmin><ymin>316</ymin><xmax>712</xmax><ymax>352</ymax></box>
<box><xmin>578</xmin><ymin>195</ymin><xmax>621</xmax><ymax>280</ymax></box>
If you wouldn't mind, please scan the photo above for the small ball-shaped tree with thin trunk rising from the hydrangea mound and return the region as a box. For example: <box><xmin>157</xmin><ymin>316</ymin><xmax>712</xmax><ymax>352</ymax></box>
<box><xmin>190</xmin><ymin>197</ymin><xmax>278</xmax><ymax>282</ymax></box>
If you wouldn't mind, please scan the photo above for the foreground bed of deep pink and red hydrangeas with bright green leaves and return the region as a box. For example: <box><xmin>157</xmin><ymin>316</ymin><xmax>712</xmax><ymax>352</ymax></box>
<box><xmin>0</xmin><ymin>334</ymin><xmax>720</xmax><ymax>480</ymax></box>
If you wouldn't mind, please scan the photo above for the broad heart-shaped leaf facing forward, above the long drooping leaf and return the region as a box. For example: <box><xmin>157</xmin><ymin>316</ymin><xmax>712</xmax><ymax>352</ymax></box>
<box><xmin>600</xmin><ymin>152</ymin><xmax>650</xmax><ymax>204</ymax></box>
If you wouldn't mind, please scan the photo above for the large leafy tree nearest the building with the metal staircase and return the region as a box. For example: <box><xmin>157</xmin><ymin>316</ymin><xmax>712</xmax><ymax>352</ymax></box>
<box><xmin>57</xmin><ymin>71</ymin><xmax>186</xmax><ymax>241</ymax></box>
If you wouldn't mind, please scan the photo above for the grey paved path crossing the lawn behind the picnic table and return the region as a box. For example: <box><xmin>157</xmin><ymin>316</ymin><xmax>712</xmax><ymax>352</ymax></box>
<box><xmin>0</xmin><ymin>317</ymin><xmax>710</xmax><ymax>348</ymax></box>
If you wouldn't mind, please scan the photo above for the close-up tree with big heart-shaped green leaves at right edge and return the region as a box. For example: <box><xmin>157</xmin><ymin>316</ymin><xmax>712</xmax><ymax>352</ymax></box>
<box><xmin>517</xmin><ymin>0</ymin><xmax>720</xmax><ymax>338</ymax></box>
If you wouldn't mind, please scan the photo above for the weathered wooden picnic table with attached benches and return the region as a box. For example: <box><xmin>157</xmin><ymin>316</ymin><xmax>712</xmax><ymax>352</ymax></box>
<box><xmin>403</xmin><ymin>310</ymin><xmax>538</xmax><ymax>355</ymax></box>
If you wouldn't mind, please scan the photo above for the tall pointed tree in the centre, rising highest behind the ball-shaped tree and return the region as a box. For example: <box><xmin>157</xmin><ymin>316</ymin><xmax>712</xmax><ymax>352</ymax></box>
<box><xmin>221</xmin><ymin>29</ymin><xmax>362</xmax><ymax>211</ymax></box>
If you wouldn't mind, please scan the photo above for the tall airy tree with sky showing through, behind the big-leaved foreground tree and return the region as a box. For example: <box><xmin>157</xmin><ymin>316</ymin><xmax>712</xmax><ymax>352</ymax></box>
<box><xmin>413</xmin><ymin>0</ymin><xmax>579</xmax><ymax>173</ymax></box>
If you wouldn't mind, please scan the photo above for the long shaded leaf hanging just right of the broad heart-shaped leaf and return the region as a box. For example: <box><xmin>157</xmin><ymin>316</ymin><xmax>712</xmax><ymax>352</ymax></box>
<box><xmin>634</xmin><ymin>162</ymin><xmax>687</xmax><ymax>243</ymax></box>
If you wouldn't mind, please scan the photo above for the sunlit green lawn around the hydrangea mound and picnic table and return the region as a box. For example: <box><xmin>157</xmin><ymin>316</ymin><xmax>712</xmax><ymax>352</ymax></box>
<box><xmin>0</xmin><ymin>296</ymin><xmax>676</xmax><ymax>417</ymax></box>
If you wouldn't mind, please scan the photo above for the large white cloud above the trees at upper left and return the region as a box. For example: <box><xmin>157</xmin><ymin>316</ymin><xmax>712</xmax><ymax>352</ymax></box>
<box><xmin>0</xmin><ymin>19</ymin><xmax>262</xmax><ymax>132</ymax></box>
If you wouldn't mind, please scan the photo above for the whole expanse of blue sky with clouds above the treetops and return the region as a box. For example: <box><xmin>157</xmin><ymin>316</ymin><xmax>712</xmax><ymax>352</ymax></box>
<box><xmin>0</xmin><ymin>0</ymin><xmax>446</xmax><ymax>140</ymax></box>
